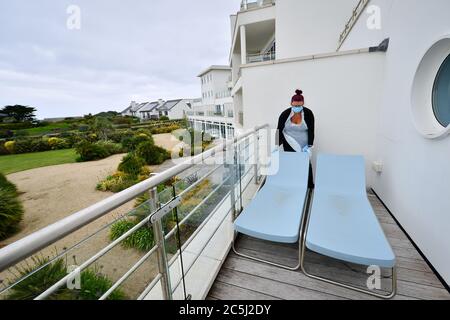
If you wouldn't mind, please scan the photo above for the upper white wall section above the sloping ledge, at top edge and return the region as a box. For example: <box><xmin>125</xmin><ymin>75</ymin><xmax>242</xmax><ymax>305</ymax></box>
<box><xmin>275</xmin><ymin>0</ymin><xmax>358</xmax><ymax>59</ymax></box>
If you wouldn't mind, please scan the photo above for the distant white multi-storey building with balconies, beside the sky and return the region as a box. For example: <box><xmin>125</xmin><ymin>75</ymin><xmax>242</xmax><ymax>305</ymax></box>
<box><xmin>188</xmin><ymin>66</ymin><xmax>235</xmax><ymax>139</ymax></box>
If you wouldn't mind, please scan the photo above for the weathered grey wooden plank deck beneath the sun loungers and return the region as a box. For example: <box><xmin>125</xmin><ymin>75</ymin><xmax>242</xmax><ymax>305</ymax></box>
<box><xmin>208</xmin><ymin>194</ymin><xmax>450</xmax><ymax>300</ymax></box>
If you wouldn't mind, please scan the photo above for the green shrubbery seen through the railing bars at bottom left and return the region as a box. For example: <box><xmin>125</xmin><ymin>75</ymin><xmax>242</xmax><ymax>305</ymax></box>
<box><xmin>6</xmin><ymin>257</ymin><xmax>126</xmax><ymax>300</ymax></box>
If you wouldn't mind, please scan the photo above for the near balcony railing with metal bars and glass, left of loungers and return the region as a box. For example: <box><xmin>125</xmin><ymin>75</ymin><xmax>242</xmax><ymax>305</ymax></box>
<box><xmin>0</xmin><ymin>125</ymin><xmax>270</xmax><ymax>300</ymax></box>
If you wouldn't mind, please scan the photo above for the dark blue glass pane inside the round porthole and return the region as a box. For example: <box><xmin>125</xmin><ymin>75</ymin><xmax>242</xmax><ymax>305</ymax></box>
<box><xmin>433</xmin><ymin>55</ymin><xmax>450</xmax><ymax>127</ymax></box>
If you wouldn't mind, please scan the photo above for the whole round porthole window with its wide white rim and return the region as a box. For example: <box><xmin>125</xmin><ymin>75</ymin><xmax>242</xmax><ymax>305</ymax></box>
<box><xmin>411</xmin><ymin>36</ymin><xmax>450</xmax><ymax>139</ymax></box>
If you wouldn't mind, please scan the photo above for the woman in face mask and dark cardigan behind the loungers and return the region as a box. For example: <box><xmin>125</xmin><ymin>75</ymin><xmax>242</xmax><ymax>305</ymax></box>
<box><xmin>278</xmin><ymin>90</ymin><xmax>315</xmax><ymax>189</ymax></box>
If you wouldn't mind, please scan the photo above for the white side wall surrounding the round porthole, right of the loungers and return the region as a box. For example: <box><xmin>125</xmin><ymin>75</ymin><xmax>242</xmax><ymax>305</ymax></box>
<box><xmin>344</xmin><ymin>0</ymin><xmax>450</xmax><ymax>284</ymax></box>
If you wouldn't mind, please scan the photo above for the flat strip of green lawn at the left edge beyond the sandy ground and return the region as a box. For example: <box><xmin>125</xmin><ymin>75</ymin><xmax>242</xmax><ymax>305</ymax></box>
<box><xmin>0</xmin><ymin>149</ymin><xmax>78</xmax><ymax>174</ymax></box>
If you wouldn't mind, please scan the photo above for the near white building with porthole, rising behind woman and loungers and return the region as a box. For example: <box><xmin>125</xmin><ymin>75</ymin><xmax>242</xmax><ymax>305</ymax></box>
<box><xmin>230</xmin><ymin>0</ymin><xmax>450</xmax><ymax>284</ymax></box>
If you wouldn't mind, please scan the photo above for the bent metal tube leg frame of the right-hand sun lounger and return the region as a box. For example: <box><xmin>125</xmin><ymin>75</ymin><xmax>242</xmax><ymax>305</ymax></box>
<box><xmin>300</xmin><ymin>200</ymin><xmax>397</xmax><ymax>299</ymax></box>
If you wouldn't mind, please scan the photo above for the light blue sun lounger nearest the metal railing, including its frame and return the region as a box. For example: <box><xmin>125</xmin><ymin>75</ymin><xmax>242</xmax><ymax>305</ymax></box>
<box><xmin>233</xmin><ymin>152</ymin><xmax>309</xmax><ymax>270</ymax></box>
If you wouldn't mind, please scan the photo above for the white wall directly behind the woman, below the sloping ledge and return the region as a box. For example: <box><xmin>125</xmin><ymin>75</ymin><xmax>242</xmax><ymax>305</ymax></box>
<box><xmin>242</xmin><ymin>53</ymin><xmax>384</xmax><ymax>186</ymax></box>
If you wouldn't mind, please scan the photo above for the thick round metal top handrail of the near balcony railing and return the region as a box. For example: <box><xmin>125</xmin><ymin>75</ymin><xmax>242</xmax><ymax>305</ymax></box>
<box><xmin>0</xmin><ymin>124</ymin><xmax>269</xmax><ymax>271</ymax></box>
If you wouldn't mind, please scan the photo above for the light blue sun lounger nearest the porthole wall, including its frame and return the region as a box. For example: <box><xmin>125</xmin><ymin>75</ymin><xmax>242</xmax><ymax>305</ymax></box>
<box><xmin>301</xmin><ymin>154</ymin><xmax>396</xmax><ymax>298</ymax></box>
